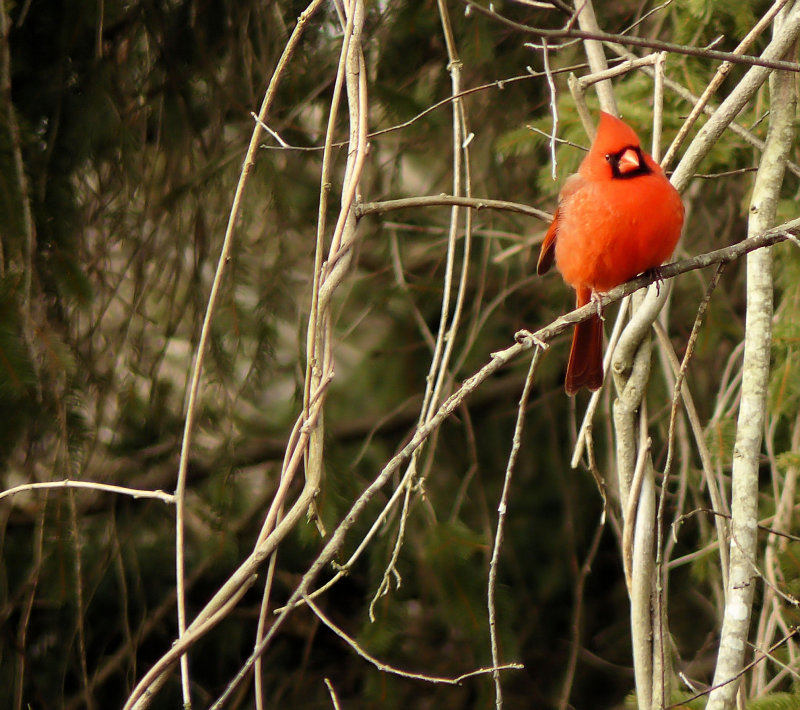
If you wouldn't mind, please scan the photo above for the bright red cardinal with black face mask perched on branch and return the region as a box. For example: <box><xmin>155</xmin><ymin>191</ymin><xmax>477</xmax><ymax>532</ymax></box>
<box><xmin>536</xmin><ymin>113</ymin><xmax>683</xmax><ymax>394</ymax></box>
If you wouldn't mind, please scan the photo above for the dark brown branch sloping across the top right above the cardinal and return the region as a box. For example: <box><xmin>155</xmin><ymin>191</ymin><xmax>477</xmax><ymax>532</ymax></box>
<box><xmin>463</xmin><ymin>0</ymin><xmax>800</xmax><ymax>72</ymax></box>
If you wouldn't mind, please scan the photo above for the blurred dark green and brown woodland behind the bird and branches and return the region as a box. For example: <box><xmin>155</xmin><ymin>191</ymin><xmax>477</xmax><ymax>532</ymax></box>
<box><xmin>0</xmin><ymin>0</ymin><xmax>800</xmax><ymax>710</ymax></box>
